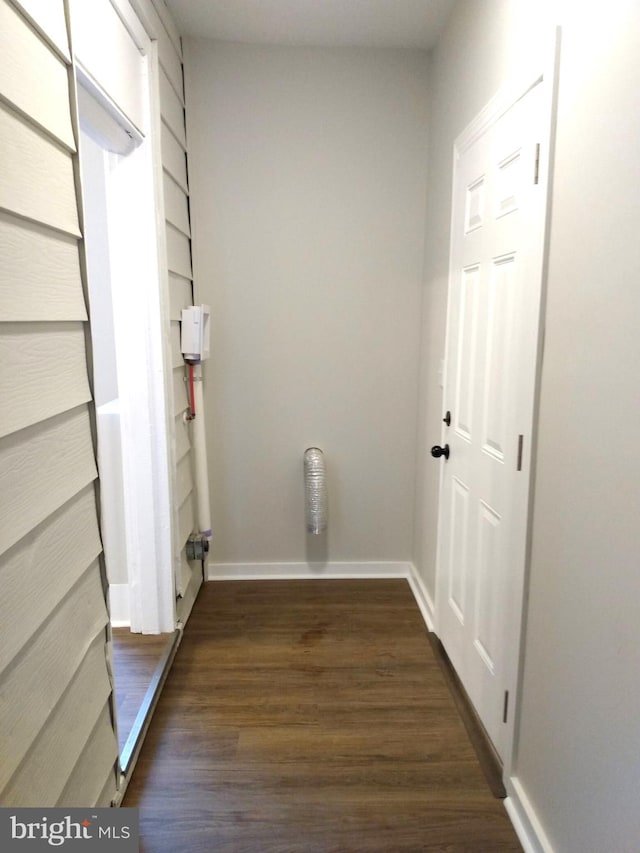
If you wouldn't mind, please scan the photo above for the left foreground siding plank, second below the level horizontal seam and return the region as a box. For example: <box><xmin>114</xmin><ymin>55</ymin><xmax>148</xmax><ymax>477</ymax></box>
<box><xmin>0</xmin><ymin>406</ymin><xmax>97</xmax><ymax>553</ymax></box>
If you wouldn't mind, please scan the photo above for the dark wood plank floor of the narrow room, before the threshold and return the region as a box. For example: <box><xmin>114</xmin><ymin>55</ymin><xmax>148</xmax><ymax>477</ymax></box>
<box><xmin>123</xmin><ymin>580</ymin><xmax>522</xmax><ymax>853</ymax></box>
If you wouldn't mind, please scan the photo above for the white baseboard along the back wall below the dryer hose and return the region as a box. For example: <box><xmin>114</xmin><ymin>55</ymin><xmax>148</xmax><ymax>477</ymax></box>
<box><xmin>207</xmin><ymin>561</ymin><xmax>411</xmax><ymax>581</ymax></box>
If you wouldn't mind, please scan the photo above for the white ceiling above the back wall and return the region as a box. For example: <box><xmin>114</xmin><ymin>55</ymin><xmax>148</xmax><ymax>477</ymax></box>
<box><xmin>165</xmin><ymin>0</ymin><xmax>455</xmax><ymax>50</ymax></box>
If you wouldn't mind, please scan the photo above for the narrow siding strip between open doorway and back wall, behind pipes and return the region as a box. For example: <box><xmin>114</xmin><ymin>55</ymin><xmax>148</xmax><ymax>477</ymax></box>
<box><xmin>150</xmin><ymin>0</ymin><xmax>202</xmax><ymax>622</ymax></box>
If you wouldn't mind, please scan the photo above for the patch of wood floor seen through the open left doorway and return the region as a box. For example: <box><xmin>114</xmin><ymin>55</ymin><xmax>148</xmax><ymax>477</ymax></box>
<box><xmin>111</xmin><ymin>628</ymin><xmax>173</xmax><ymax>752</ymax></box>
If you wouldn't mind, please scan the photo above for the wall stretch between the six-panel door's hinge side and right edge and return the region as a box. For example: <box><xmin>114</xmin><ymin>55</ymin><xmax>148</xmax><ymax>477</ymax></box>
<box><xmin>517</xmin><ymin>2</ymin><xmax>640</xmax><ymax>853</ymax></box>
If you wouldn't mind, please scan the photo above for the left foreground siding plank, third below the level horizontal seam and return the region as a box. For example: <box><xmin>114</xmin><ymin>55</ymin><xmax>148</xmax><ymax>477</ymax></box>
<box><xmin>0</xmin><ymin>485</ymin><xmax>102</xmax><ymax>673</ymax></box>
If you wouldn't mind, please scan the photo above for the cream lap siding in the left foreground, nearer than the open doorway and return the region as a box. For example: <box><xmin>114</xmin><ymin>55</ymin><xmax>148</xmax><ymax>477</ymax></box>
<box><xmin>0</xmin><ymin>0</ymin><xmax>118</xmax><ymax>807</ymax></box>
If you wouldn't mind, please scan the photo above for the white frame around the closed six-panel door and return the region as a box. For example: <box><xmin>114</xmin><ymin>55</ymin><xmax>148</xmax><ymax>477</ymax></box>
<box><xmin>434</xmin><ymin>27</ymin><xmax>561</xmax><ymax>780</ymax></box>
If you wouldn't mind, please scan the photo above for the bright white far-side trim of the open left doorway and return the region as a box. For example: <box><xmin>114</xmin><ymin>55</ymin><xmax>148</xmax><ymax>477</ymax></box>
<box><xmin>71</xmin><ymin>0</ymin><xmax>176</xmax><ymax>633</ymax></box>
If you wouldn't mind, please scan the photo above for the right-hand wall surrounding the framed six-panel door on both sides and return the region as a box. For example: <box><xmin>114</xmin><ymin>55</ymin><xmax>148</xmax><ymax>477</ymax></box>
<box><xmin>416</xmin><ymin>0</ymin><xmax>640</xmax><ymax>853</ymax></box>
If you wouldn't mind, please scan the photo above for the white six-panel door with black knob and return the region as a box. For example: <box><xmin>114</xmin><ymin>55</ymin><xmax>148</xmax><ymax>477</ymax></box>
<box><xmin>436</xmin><ymin>82</ymin><xmax>547</xmax><ymax>756</ymax></box>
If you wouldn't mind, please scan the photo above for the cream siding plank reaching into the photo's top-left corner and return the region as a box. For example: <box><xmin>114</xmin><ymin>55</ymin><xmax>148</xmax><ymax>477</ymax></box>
<box><xmin>0</xmin><ymin>0</ymin><xmax>75</xmax><ymax>150</ymax></box>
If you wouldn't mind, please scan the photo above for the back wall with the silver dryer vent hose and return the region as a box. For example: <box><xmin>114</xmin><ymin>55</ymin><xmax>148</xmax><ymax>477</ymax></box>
<box><xmin>185</xmin><ymin>39</ymin><xmax>428</xmax><ymax>563</ymax></box>
